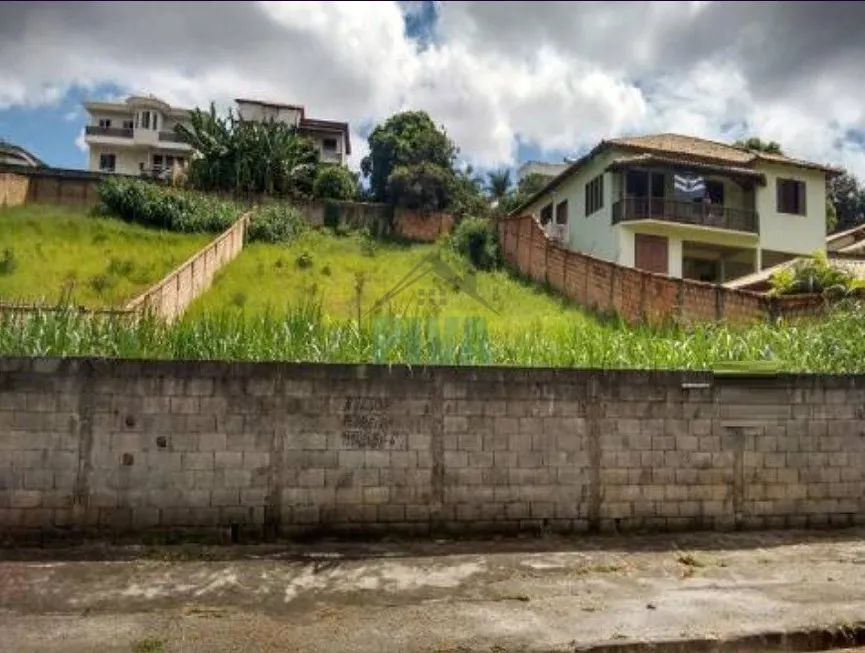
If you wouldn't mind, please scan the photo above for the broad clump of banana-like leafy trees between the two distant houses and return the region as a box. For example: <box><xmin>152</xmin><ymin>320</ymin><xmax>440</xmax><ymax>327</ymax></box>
<box><xmin>175</xmin><ymin>104</ymin><xmax>319</xmax><ymax>197</ymax></box>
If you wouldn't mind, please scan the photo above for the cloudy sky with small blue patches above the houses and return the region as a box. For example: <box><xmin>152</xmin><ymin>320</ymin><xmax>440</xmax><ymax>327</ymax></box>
<box><xmin>0</xmin><ymin>1</ymin><xmax>865</xmax><ymax>178</ymax></box>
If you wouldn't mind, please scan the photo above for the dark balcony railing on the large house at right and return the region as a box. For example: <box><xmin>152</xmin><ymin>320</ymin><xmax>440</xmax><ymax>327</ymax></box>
<box><xmin>613</xmin><ymin>197</ymin><xmax>760</xmax><ymax>233</ymax></box>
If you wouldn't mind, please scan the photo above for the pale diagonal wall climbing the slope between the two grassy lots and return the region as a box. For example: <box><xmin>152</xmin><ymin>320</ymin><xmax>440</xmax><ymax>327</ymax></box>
<box><xmin>126</xmin><ymin>213</ymin><xmax>250</xmax><ymax>321</ymax></box>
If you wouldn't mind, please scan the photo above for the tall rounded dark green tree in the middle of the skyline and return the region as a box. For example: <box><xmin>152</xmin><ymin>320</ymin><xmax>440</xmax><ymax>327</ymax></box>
<box><xmin>361</xmin><ymin>111</ymin><xmax>457</xmax><ymax>210</ymax></box>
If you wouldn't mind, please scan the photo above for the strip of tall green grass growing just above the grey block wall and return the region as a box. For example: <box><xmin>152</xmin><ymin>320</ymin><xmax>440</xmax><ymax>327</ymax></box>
<box><xmin>0</xmin><ymin>301</ymin><xmax>865</xmax><ymax>373</ymax></box>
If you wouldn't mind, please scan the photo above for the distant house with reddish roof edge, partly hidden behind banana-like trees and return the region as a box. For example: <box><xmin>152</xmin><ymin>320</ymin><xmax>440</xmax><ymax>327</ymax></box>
<box><xmin>235</xmin><ymin>98</ymin><xmax>351</xmax><ymax>165</ymax></box>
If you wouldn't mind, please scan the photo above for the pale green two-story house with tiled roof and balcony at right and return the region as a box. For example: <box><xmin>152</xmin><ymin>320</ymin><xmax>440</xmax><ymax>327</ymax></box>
<box><xmin>515</xmin><ymin>134</ymin><xmax>838</xmax><ymax>283</ymax></box>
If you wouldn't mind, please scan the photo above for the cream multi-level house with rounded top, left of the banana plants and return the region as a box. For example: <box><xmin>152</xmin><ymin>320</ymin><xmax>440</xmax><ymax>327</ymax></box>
<box><xmin>84</xmin><ymin>95</ymin><xmax>192</xmax><ymax>176</ymax></box>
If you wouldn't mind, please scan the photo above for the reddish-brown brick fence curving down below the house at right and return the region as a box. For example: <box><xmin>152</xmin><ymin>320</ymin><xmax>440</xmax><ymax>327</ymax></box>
<box><xmin>498</xmin><ymin>215</ymin><xmax>827</xmax><ymax>324</ymax></box>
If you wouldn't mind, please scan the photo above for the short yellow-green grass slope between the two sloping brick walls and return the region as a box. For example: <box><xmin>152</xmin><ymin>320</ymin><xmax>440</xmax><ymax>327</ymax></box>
<box><xmin>187</xmin><ymin>231</ymin><xmax>595</xmax><ymax>331</ymax></box>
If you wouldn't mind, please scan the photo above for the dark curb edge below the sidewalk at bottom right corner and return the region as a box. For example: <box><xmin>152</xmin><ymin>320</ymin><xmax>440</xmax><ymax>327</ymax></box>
<box><xmin>572</xmin><ymin>622</ymin><xmax>865</xmax><ymax>653</ymax></box>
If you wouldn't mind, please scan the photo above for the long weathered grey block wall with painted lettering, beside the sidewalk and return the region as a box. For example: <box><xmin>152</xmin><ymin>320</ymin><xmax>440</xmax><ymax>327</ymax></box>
<box><xmin>0</xmin><ymin>358</ymin><xmax>865</xmax><ymax>536</ymax></box>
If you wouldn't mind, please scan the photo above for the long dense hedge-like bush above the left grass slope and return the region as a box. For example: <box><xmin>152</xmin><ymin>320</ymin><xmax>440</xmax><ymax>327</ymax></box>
<box><xmin>97</xmin><ymin>177</ymin><xmax>240</xmax><ymax>233</ymax></box>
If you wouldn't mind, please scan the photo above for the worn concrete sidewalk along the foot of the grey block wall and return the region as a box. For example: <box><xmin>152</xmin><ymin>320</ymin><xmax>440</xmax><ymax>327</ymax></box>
<box><xmin>0</xmin><ymin>530</ymin><xmax>865</xmax><ymax>653</ymax></box>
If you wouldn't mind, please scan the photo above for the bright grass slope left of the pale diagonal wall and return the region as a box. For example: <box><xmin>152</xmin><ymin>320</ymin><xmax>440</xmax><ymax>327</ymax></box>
<box><xmin>0</xmin><ymin>204</ymin><xmax>212</xmax><ymax>308</ymax></box>
